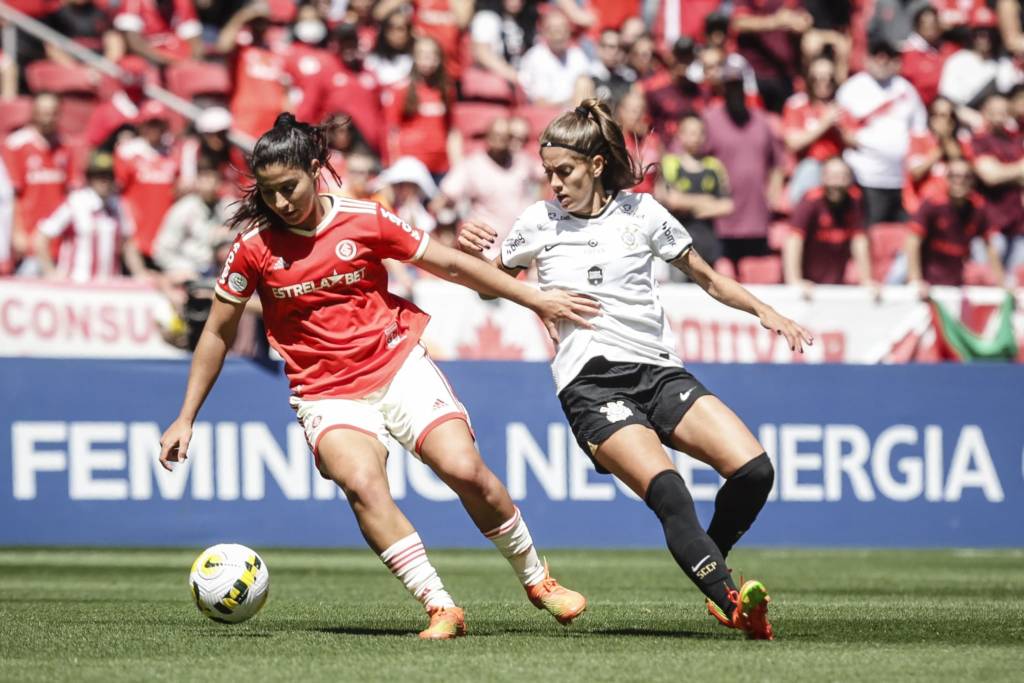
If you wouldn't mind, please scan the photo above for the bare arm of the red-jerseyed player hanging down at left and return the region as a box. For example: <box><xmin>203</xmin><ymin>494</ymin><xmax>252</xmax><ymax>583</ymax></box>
<box><xmin>160</xmin><ymin>296</ymin><xmax>246</xmax><ymax>471</ymax></box>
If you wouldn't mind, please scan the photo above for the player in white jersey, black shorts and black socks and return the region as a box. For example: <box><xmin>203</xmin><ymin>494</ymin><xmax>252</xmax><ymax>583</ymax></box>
<box><xmin>459</xmin><ymin>99</ymin><xmax>812</xmax><ymax>640</ymax></box>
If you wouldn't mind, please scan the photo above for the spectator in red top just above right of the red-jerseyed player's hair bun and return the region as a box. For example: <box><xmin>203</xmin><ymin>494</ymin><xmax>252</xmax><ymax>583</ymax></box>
<box><xmin>296</xmin><ymin>24</ymin><xmax>384</xmax><ymax>154</ymax></box>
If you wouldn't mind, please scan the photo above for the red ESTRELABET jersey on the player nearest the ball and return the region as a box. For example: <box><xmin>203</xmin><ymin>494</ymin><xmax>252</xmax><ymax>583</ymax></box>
<box><xmin>216</xmin><ymin>195</ymin><xmax>430</xmax><ymax>399</ymax></box>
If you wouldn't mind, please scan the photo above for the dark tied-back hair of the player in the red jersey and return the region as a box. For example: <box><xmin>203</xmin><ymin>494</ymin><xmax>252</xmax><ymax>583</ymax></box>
<box><xmin>227</xmin><ymin>112</ymin><xmax>349</xmax><ymax>228</ymax></box>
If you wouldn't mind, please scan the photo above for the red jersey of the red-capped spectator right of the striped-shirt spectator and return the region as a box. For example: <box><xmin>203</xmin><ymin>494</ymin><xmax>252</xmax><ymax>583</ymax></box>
<box><xmin>114</xmin><ymin>137</ymin><xmax>180</xmax><ymax>256</ymax></box>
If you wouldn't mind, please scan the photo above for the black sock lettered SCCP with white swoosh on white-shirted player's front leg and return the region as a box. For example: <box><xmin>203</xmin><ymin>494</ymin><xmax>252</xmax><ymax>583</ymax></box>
<box><xmin>644</xmin><ymin>470</ymin><xmax>736</xmax><ymax>614</ymax></box>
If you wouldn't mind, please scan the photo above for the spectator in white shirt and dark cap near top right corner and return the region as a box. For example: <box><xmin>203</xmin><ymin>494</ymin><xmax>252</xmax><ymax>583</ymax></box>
<box><xmin>939</xmin><ymin>6</ymin><xmax>1024</xmax><ymax>112</ymax></box>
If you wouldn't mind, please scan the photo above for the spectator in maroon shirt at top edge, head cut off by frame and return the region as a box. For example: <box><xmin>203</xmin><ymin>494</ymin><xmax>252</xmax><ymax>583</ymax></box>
<box><xmin>732</xmin><ymin>0</ymin><xmax>813</xmax><ymax>113</ymax></box>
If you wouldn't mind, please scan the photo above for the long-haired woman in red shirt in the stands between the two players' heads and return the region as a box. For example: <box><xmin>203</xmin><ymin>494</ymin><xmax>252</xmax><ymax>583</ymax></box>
<box><xmin>384</xmin><ymin>37</ymin><xmax>460</xmax><ymax>177</ymax></box>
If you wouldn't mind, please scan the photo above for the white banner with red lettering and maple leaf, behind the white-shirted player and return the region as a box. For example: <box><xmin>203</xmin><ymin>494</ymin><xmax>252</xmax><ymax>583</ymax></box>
<box><xmin>415</xmin><ymin>281</ymin><xmax>1024</xmax><ymax>364</ymax></box>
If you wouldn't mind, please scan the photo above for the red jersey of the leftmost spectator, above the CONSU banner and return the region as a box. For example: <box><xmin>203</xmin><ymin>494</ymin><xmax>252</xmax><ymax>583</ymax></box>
<box><xmin>3</xmin><ymin>126</ymin><xmax>72</xmax><ymax>242</ymax></box>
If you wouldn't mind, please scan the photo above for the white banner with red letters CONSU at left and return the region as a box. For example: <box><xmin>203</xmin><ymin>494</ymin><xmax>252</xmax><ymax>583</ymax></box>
<box><xmin>0</xmin><ymin>279</ymin><xmax>184</xmax><ymax>358</ymax></box>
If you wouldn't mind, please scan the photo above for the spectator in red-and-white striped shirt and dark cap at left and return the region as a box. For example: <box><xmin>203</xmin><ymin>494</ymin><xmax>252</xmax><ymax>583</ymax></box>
<box><xmin>36</xmin><ymin>153</ymin><xmax>146</xmax><ymax>283</ymax></box>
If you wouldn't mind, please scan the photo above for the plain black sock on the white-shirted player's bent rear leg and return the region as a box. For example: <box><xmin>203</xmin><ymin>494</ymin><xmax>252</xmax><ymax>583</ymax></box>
<box><xmin>708</xmin><ymin>453</ymin><xmax>775</xmax><ymax>557</ymax></box>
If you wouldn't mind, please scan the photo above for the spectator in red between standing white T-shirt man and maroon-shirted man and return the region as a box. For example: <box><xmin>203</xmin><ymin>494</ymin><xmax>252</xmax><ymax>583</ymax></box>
<box><xmin>903</xmin><ymin>97</ymin><xmax>970</xmax><ymax>214</ymax></box>
